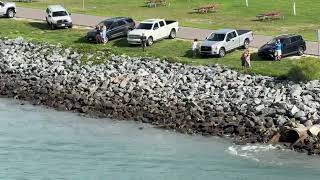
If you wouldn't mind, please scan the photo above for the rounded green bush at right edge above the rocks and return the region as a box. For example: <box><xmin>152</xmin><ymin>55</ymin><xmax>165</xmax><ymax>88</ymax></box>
<box><xmin>288</xmin><ymin>58</ymin><xmax>320</xmax><ymax>81</ymax></box>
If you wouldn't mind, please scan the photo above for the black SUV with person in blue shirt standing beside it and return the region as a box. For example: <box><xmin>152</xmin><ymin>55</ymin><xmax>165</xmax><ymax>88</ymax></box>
<box><xmin>258</xmin><ymin>34</ymin><xmax>307</xmax><ymax>59</ymax></box>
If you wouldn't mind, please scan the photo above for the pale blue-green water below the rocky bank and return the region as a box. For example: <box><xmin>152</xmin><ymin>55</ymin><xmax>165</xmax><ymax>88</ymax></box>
<box><xmin>0</xmin><ymin>99</ymin><xmax>320</xmax><ymax>180</ymax></box>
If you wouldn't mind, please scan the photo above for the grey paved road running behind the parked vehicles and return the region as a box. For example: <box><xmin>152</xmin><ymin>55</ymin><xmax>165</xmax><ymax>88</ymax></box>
<box><xmin>16</xmin><ymin>7</ymin><xmax>318</xmax><ymax>55</ymax></box>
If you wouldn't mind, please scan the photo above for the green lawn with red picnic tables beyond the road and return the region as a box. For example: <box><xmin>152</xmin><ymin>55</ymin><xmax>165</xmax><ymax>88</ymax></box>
<box><xmin>18</xmin><ymin>0</ymin><xmax>320</xmax><ymax>40</ymax></box>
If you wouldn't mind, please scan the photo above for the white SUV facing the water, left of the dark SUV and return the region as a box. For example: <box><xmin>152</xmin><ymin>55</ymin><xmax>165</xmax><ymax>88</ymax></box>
<box><xmin>46</xmin><ymin>5</ymin><xmax>72</xmax><ymax>29</ymax></box>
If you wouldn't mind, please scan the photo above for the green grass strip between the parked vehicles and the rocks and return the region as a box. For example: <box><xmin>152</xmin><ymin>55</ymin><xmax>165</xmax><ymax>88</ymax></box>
<box><xmin>0</xmin><ymin>19</ymin><xmax>319</xmax><ymax>78</ymax></box>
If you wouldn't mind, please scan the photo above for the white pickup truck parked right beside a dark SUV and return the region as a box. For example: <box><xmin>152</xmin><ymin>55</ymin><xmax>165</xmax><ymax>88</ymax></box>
<box><xmin>127</xmin><ymin>19</ymin><xmax>179</xmax><ymax>46</ymax></box>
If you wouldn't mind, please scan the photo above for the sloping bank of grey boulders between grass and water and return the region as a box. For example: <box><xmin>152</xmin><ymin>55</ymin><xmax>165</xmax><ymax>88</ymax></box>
<box><xmin>0</xmin><ymin>38</ymin><xmax>320</xmax><ymax>154</ymax></box>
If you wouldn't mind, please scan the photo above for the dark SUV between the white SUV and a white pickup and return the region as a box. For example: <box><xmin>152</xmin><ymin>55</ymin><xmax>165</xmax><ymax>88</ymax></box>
<box><xmin>85</xmin><ymin>17</ymin><xmax>135</xmax><ymax>42</ymax></box>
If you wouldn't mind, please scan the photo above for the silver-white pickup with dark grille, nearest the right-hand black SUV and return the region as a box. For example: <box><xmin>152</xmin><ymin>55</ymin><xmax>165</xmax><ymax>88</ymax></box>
<box><xmin>200</xmin><ymin>29</ymin><xmax>253</xmax><ymax>57</ymax></box>
